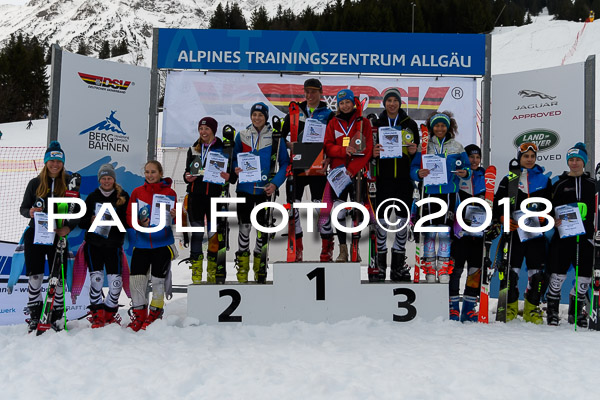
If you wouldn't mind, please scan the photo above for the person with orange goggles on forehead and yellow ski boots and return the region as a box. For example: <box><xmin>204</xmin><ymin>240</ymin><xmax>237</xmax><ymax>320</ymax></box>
<box><xmin>494</xmin><ymin>142</ymin><xmax>552</xmax><ymax>324</ymax></box>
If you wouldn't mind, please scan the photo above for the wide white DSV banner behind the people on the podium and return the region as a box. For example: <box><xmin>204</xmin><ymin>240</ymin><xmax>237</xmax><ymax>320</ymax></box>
<box><xmin>162</xmin><ymin>71</ymin><xmax>480</xmax><ymax>147</ymax></box>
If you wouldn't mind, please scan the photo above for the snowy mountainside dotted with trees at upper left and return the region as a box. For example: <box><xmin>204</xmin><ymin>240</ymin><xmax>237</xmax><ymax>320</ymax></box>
<box><xmin>0</xmin><ymin>0</ymin><xmax>331</xmax><ymax>66</ymax></box>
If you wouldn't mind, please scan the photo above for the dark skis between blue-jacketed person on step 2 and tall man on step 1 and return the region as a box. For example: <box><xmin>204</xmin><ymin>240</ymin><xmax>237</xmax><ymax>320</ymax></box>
<box><xmin>256</xmin><ymin>116</ymin><xmax>284</xmax><ymax>284</ymax></box>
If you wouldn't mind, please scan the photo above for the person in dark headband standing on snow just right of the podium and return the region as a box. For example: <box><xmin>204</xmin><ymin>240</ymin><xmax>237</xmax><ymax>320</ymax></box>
<box><xmin>448</xmin><ymin>144</ymin><xmax>485</xmax><ymax>322</ymax></box>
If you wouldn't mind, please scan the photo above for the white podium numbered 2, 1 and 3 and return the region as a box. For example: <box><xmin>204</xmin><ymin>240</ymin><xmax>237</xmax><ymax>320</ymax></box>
<box><xmin>188</xmin><ymin>262</ymin><xmax>448</xmax><ymax>325</ymax></box>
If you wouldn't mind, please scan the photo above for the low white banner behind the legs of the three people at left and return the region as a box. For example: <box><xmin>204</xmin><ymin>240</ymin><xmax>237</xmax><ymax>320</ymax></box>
<box><xmin>0</xmin><ymin>242</ymin><xmax>90</xmax><ymax>325</ymax></box>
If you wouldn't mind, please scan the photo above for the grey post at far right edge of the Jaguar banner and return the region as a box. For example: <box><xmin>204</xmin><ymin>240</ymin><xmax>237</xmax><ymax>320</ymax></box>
<box><xmin>583</xmin><ymin>54</ymin><xmax>596</xmax><ymax>176</ymax></box>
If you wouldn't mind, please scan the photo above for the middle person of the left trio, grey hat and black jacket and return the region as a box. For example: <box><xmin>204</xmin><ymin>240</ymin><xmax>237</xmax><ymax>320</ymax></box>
<box><xmin>79</xmin><ymin>164</ymin><xmax>129</xmax><ymax>328</ymax></box>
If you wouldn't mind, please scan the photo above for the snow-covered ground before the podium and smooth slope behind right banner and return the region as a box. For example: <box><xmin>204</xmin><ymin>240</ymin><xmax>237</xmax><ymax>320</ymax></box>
<box><xmin>0</xmin><ymin>10</ymin><xmax>600</xmax><ymax>399</ymax></box>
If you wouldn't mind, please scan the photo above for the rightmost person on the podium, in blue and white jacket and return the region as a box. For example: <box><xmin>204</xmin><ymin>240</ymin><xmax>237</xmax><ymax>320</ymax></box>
<box><xmin>410</xmin><ymin>111</ymin><xmax>471</xmax><ymax>283</ymax></box>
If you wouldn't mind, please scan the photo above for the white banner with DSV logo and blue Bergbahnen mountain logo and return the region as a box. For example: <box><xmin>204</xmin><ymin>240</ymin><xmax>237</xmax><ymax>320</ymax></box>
<box><xmin>58</xmin><ymin>51</ymin><xmax>150</xmax><ymax>198</ymax></box>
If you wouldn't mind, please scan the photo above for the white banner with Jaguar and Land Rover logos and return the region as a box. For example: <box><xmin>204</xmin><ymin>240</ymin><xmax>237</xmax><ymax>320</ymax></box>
<box><xmin>490</xmin><ymin>63</ymin><xmax>594</xmax><ymax>177</ymax></box>
